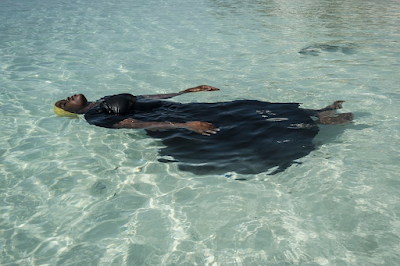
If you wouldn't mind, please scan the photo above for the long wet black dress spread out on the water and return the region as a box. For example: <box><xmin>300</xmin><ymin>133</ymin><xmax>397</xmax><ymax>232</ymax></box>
<box><xmin>85</xmin><ymin>96</ymin><xmax>318</xmax><ymax>174</ymax></box>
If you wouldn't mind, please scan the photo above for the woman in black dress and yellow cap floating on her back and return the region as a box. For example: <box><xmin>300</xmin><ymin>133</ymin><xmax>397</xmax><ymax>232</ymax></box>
<box><xmin>54</xmin><ymin>85</ymin><xmax>353</xmax><ymax>174</ymax></box>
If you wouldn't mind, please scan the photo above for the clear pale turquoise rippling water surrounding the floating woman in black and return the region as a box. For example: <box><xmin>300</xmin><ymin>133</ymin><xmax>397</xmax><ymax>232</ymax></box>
<box><xmin>0</xmin><ymin>0</ymin><xmax>400</xmax><ymax>265</ymax></box>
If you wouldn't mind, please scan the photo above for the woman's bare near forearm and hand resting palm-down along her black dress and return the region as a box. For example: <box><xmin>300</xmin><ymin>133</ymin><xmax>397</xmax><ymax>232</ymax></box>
<box><xmin>113</xmin><ymin>118</ymin><xmax>219</xmax><ymax>136</ymax></box>
